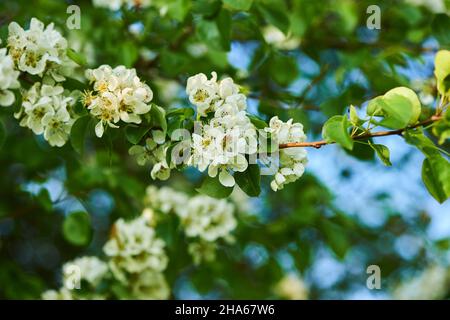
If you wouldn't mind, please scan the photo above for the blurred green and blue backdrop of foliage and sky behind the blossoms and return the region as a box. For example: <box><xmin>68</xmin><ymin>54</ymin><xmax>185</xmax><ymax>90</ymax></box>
<box><xmin>0</xmin><ymin>0</ymin><xmax>450</xmax><ymax>299</ymax></box>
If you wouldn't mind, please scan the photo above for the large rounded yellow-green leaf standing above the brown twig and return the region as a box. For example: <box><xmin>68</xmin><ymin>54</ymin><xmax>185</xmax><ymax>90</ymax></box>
<box><xmin>367</xmin><ymin>87</ymin><xmax>421</xmax><ymax>129</ymax></box>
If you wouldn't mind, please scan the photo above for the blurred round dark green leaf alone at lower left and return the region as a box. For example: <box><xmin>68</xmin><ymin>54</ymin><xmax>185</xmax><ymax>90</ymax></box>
<box><xmin>62</xmin><ymin>211</ymin><xmax>92</xmax><ymax>246</ymax></box>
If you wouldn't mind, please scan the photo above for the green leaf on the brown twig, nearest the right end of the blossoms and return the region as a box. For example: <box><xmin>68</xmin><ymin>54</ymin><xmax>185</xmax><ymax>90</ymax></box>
<box><xmin>322</xmin><ymin>116</ymin><xmax>353</xmax><ymax>150</ymax></box>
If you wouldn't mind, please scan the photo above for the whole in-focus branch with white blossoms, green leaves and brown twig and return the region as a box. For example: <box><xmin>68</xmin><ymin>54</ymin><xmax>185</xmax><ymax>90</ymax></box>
<box><xmin>0</xmin><ymin>18</ymin><xmax>450</xmax><ymax>202</ymax></box>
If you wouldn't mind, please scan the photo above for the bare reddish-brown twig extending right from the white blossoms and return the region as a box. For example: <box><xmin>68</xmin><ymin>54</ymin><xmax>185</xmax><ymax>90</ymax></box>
<box><xmin>279</xmin><ymin>115</ymin><xmax>442</xmax><ymax>149</ymax></box>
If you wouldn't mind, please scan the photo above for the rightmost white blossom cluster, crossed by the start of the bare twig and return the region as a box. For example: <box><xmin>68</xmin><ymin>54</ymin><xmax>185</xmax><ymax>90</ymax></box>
<box><xmin>265</xmin><ymin>117</ymin><xmax>307</xmax><ymax>191</ymax></box>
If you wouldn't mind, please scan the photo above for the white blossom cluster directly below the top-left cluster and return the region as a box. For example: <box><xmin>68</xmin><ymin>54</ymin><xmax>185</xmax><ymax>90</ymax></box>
<box><xmin>14</xmin><ymin>82</ymin><xmax>77</xmax><ymax>147</ymax></box>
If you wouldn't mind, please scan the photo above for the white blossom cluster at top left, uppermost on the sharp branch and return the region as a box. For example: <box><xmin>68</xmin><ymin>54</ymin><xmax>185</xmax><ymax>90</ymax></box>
<box><xmin>8</xmin><ymin>18</ymin><xmax>74</xmax><ymax>82</ymax></box>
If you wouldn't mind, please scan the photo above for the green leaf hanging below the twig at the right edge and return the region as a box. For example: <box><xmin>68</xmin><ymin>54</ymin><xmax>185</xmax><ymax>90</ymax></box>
<box><xmin>422</xmin><ymin>155</ymin><xmax>450</xmax><ymax>203</ymax></box>
